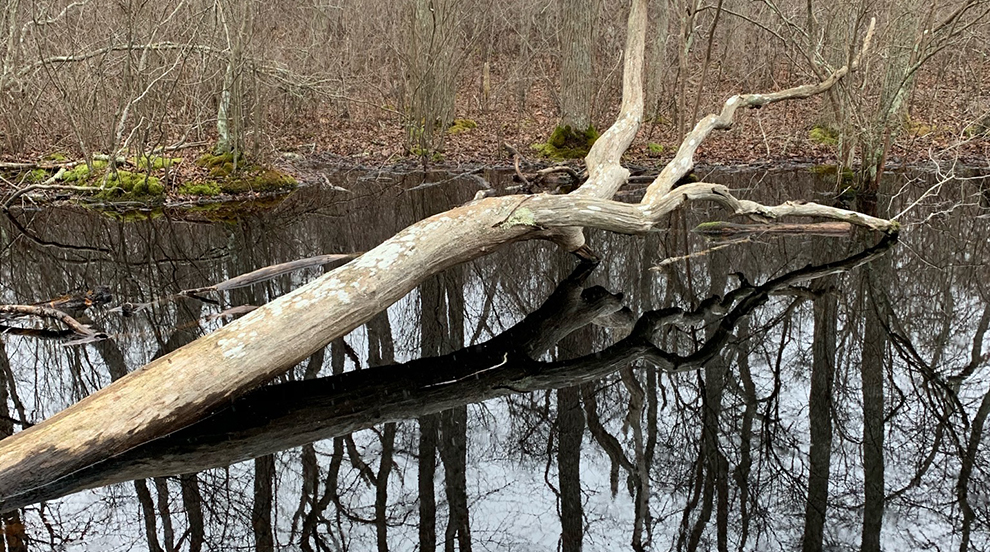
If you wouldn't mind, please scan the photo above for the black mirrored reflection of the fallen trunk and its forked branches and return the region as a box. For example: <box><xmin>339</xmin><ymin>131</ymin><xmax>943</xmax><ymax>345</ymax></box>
<box><xmin>0</xmin><ymin>238</ymin><xmax>893</xmax><ymax>511</ymax></box>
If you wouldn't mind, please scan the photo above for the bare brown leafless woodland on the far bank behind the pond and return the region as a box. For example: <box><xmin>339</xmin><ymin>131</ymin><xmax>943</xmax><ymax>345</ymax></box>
<box><xmin>0</xmin><ymin>0</ymin><xmax>990</xmax><ymax>175</ymax></box>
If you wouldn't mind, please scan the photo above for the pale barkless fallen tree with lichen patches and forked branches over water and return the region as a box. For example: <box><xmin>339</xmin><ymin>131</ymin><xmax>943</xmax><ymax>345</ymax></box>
<box><xmin>0</xmin><ymin>0</ymin><xmax>898</xmax><ymax>506</ymax></box>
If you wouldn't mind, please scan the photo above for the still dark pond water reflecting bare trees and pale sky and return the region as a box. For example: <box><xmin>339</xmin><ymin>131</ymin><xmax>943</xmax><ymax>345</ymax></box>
<box><xmin>0</xmin><ymin>169</ymin><xmax>990</xmax><ymax>551</ymax></box>
